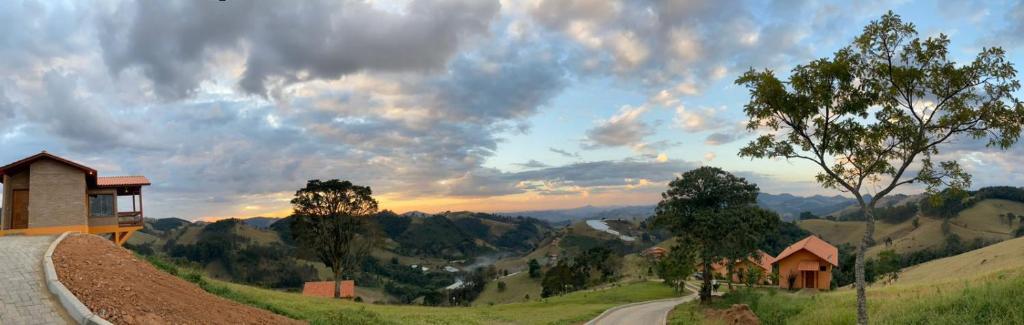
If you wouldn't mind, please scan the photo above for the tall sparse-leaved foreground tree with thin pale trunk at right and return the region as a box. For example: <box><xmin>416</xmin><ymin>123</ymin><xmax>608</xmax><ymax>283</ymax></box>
<box><xmin>736</xmin><ymin>11</ymin><xmax>1024</xmax><ymax>324</ymax></box>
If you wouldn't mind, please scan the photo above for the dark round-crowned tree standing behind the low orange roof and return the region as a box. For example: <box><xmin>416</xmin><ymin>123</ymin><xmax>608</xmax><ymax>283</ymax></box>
<box><xmin>292</xmin><ymin>179</ymin><xmax>379</xmax><ymax>298</ymax></box>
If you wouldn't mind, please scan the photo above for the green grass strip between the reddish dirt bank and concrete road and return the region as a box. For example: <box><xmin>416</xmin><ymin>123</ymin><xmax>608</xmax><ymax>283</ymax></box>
<box><xmin>203</xmin><ymin>280</ymin><xmax>674</xmax><ymax>324</ymax></box>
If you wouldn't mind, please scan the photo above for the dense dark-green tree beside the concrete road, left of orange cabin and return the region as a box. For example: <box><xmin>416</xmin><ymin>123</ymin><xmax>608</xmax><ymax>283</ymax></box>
<box><xmin>654</xmin><ymin>166</ymin><xmax>779</xmax><ymax>302</ymax></box>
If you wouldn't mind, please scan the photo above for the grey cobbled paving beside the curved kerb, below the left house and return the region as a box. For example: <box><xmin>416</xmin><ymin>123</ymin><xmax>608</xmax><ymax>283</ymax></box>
<box><xmin>0</xmin><ymin>236</ymin><xmax>71</xmax><ymax>325</ymax></box>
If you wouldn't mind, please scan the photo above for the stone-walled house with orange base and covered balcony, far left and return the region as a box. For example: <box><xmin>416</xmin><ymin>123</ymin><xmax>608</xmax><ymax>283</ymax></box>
<box><xmin>0</xmin><ymin>151</ymin><xmax>150</xmax><ymax>245</ymax></box>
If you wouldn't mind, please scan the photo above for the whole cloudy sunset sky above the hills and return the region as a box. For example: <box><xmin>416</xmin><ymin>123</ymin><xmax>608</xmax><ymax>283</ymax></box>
<box><xmin>0</xmin><ymin>0</ymin><xmax>1024</xmax><ymax>219</ymax></box>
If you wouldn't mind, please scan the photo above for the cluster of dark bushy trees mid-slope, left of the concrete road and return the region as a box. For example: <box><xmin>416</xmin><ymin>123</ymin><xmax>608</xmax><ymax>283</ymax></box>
<box><xmin>530</xmin><ymin>247</ymin><xmax>623</xmax><ymax>297</ymax></box>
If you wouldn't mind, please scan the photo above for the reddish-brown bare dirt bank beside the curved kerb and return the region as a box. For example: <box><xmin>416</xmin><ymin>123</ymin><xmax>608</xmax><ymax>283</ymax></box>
<box><xmin>53</xmin><ymin>235</ymin><xmax>303</xmax><ymax>324</ymax></box>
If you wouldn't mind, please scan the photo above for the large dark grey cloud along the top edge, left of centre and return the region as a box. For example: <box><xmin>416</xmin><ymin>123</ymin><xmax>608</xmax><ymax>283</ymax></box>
<box><xmin>98</xmin><ymin>0</ymin><xmax>500</xmax><ymax>97</ymax></box>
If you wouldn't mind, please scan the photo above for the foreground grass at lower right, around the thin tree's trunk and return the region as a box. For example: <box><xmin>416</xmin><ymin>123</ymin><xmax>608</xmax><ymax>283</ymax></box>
<box><xmin>672</xmin><ymin>238</ymin><xmax>1024</xmax><ymax>324</ymax></box>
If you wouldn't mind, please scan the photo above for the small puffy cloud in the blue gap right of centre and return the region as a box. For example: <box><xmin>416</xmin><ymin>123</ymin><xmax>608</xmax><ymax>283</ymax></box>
<box><xmin>584</xmin><ymin>106</ymin><xmax>654</xmax><ymax>149</ymax></box>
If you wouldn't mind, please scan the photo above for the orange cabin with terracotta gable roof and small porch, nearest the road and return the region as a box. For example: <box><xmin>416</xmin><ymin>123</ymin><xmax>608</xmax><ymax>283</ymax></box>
<box><xmin>772</xmin><ymin>235</ymin><xmax>839</xmax><ymax>290</ymax></box>
